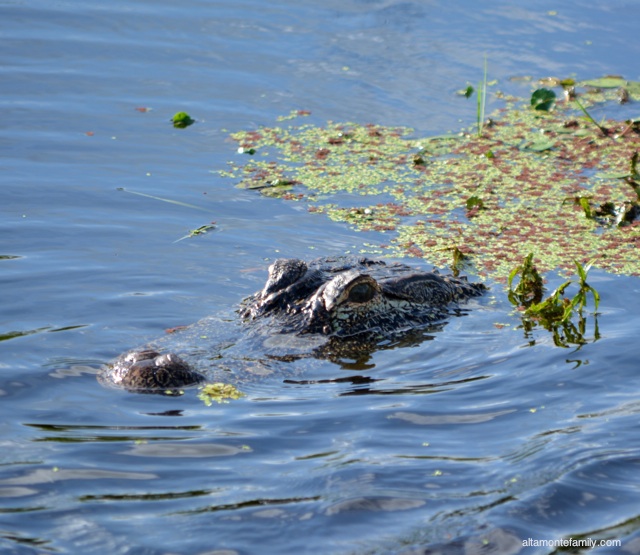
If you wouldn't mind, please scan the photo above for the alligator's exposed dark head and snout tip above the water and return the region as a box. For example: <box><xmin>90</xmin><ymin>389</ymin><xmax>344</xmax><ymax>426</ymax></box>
<box><xmin>99</xmin><ymin>256</ymin><xmax>486</xmax><ymax>393</ymax></box>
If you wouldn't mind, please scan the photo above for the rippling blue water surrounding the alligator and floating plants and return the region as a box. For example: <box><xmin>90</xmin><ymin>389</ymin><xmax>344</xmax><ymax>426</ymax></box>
<box><xmin>0</xmin><ymin>0</ymin><xmax>640</xmax><ymax>555</ymax></box>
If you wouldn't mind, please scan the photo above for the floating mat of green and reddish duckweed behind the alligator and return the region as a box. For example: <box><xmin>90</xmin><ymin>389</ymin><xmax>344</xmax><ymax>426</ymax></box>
<box><xmin>221</xmin><ymin>77</ymin><xmax>640</xmax><ymax>281</ymax></box>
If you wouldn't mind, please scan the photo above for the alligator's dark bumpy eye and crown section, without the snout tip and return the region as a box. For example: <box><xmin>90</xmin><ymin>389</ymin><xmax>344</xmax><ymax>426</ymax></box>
<box><xmin>241</xmin><ymin>257</ymin><xmax>486</xmax><ymax>337</ymax></box>
